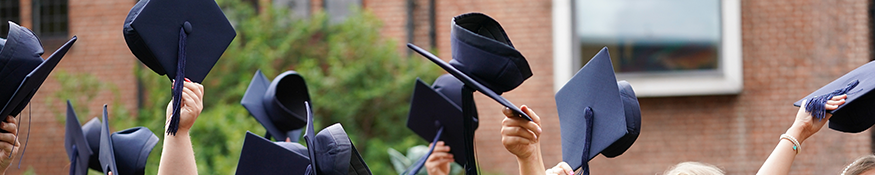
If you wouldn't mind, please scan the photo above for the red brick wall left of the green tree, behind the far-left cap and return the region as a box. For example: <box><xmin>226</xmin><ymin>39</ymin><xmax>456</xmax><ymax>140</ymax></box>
<box><xmin>7</xmin><ymin>0</ymin><xmax>138</xmax><ymax>174</ymax></box>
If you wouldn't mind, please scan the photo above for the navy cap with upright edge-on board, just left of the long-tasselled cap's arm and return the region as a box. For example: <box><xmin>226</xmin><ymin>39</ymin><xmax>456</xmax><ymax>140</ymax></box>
<box><xmin>99</xmin><ymin>105</ymin><xmax>158</xmax><ymax>175</ymax></box>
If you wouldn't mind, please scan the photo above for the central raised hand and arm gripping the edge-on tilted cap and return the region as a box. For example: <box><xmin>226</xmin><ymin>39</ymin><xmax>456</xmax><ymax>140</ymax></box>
<box><xmin>501</xmin><ymin>105</ymin><xmax>546</xmax><ymax>174</ymax></box>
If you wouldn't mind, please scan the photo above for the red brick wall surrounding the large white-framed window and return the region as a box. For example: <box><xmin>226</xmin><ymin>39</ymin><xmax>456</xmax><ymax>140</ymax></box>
<box><xmin>366</xmin><ymin>0</ymin><xmax>871</xmax><ymax>174</ymax></box>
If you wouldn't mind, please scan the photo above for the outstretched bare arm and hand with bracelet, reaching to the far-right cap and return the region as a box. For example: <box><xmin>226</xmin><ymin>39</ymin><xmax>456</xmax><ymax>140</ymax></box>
<box><xmin>757</xmin><ymin>95</ymin><xmax>847</xmax><ymax>174</ymax></box>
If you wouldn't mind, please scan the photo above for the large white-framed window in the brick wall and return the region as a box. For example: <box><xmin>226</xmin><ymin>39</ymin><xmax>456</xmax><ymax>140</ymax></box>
<box><xmin>553</xmin><ymin>0</ymin><xmax>742</xmax><ymax>97</ymax></box>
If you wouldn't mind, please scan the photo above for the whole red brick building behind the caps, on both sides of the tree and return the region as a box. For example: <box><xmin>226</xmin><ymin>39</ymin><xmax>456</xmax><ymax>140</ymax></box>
<box><xmin>0</xmin><ymin>0</ymin><xmax>873</xmax><ymax>174</ymax></box>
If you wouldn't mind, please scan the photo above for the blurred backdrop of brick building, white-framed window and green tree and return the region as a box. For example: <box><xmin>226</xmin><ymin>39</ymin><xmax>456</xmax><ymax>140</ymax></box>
<box><xmin>0</xmin><ymin>0</ymin><xmax>875</xmax><ymax>174</ymax></box>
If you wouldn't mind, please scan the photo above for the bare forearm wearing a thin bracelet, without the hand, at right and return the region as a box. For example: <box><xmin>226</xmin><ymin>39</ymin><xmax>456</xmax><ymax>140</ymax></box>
<box><xmin>757</xmin><ymin>127</ymin><xmax>803</xmax><ymax>175</ymax></box>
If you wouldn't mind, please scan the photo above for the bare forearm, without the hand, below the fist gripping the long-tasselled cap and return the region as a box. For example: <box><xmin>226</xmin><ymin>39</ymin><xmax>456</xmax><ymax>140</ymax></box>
<box><xmin>158</xmin><ymin>130</ymin><xmax>197</xmax><ymax>175</ymax></box>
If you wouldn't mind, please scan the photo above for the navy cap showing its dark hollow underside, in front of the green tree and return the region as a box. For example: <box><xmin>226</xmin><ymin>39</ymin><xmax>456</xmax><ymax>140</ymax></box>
<box><xmin>240</xmin><ymin>70</ymin><xmax>310</xmax><ymax>142</ymax></box>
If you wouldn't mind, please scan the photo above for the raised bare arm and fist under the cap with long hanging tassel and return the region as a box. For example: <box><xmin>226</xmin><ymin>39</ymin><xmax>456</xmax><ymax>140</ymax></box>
<box><xmin>158</xmin><ymin>79</ymin><xmax>204</xmax><ymax>175</ymax></box>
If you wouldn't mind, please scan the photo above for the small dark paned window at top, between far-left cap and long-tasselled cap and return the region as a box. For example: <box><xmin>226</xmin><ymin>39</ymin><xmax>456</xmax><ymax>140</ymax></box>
<box><xmin>32</xmin><ymin>0</ymin><xmax>69</xmax><ymax>37</ymax></box>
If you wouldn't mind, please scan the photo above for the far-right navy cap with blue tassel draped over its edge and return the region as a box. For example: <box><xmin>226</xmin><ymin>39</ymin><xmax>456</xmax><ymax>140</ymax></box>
<box><xmin>793</xmin><ymin>62</ymin><xmax>875</xmax><ymax>133</ymax></box>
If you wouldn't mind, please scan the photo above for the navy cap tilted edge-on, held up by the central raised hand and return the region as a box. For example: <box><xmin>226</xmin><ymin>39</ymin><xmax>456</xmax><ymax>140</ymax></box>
<box><xmin>407</xmin><ymin>13</ymin><xmax>532</xmax><ymax>121</ymax></box>
